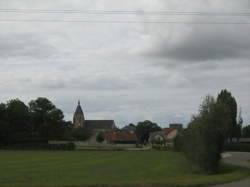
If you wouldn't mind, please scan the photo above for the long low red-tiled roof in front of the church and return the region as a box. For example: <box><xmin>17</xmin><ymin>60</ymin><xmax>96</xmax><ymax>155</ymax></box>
<box><xmin>105</xmin><ymin>133</ymin><xmax>137</xmax><ymax>142</ymax></box>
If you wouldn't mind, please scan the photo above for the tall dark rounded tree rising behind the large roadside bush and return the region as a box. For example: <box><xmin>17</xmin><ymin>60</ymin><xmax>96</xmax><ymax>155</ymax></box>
<box><xmin>217</xmin><ymin>90</ymin><xmax>238</xmax><ymax>141</ymax></box>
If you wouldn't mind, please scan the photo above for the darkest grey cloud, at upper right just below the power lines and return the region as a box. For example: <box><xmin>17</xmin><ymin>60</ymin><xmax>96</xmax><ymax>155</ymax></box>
<box><xmin>146</xmin><ymin>25</ymin><xmax>250</xmax><ymax>62</ymax></box>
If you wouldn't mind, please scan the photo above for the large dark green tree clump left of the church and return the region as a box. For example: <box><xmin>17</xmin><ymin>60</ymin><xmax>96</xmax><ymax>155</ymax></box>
<box><xmin>0</xmin><ymin>97</ymin><xmax>72</xmax><ymax>144</ymax></box>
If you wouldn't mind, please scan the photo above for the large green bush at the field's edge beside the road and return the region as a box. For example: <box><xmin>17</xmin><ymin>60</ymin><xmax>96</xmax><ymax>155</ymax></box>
<box><xmin>179</xmin><ymin>96</ymin><xmax>230</xmax><ymax>174</ymax></box>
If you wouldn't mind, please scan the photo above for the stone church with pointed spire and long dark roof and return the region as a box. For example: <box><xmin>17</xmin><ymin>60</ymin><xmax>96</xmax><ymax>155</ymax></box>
<box><xmin>73</xmin><ymin>101</ymin><xmax>116</xmax><ymax>131</ymax></box>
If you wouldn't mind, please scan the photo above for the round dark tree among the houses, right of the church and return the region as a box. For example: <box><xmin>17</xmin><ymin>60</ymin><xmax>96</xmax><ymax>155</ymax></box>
<box><xmin>135</xmin><ymin>120</ymin><xmax>161</xmax><ymax>144</ymax></box>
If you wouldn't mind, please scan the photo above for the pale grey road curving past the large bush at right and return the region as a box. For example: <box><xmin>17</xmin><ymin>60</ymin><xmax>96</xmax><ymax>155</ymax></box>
<box><xmin>213</xmin><ymin>152</ymin><xmax>250</xmax><ymax>187</ymax></box>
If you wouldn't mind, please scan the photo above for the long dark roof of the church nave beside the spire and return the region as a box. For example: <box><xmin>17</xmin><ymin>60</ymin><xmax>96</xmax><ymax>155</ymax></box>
<box><xmin>85</xmin><ymin>120</ymin><xmax>115</xmax><ymax>130</ymax></box>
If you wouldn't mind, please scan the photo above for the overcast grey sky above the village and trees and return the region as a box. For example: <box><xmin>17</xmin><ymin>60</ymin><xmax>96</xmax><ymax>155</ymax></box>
<box><xmin>0</xmin><ymin>0</ymin><xmax>250</xmax><ymax>127</ymax></box>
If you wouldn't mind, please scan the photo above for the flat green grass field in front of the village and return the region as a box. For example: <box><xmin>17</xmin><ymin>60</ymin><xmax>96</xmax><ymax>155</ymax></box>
<box><xmin>0</xmin><ymin>151</ymin><xmax>249</xmax><ymax>186</ymax></box>
